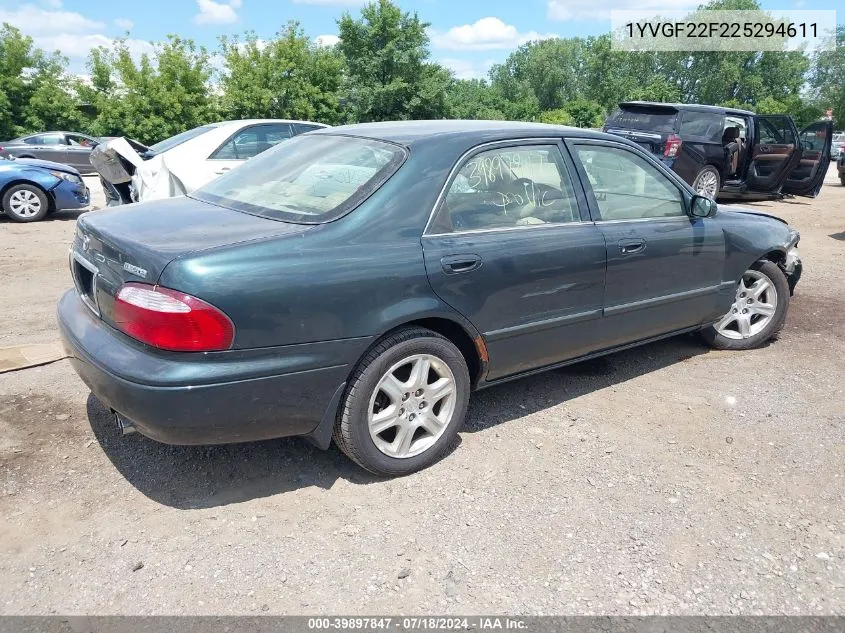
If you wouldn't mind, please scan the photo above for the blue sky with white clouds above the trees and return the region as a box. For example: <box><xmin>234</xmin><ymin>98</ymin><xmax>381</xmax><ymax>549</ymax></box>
<box><xmin>0</xmin><ymin>0</ymin><xmax>845</xmax><ymax>79</ymax></box>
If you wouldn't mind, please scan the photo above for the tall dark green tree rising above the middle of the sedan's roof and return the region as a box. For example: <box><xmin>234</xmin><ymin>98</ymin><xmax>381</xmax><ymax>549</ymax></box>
<box><xmin>337</xmin><ymin>0</ymin><xmax>451</xmax><ymax>121</ymax></box>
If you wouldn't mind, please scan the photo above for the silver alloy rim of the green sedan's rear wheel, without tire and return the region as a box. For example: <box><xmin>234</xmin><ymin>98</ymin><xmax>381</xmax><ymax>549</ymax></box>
<box><xmin>367</xmin><ymin>354</ymin><xmax>457</xmax><ymax>459</ymax></box>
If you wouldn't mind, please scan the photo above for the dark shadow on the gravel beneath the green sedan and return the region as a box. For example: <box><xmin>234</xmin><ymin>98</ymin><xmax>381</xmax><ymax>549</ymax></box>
<box><xmin>87</xmin><ymin>336</ymin><xmax>708</xmax><ymax>509</ymax></box>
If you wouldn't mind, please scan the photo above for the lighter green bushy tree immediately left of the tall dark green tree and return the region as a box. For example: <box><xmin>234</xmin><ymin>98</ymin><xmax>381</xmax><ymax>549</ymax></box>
<box><xmin>220</xmin><ymin>22</ymin><xmax>344</xmax><ymax>124</ymax></box>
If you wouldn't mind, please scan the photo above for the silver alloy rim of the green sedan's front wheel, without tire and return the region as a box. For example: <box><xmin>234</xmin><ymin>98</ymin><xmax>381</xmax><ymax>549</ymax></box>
<box><xmin>714</xmin><ymin>270</ymin><xmax>778</xmax><ymax>340</ymax></box>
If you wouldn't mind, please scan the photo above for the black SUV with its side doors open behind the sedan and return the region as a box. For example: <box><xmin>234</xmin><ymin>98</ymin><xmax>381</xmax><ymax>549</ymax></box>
<box><xmin>602</xmin><ymin>101</ymin><xmax>833</xmax><ymax>200</ymax></box>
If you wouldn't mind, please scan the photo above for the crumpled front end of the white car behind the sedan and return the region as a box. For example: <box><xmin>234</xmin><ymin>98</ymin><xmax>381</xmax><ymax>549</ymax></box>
<box><xmin>90</xmin><ymin>137</ymin><xmax>188</xmax><ymax>204</ymax></box>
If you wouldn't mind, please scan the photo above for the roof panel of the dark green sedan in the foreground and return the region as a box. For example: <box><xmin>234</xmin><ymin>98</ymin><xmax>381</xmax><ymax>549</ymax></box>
<box><xmin>310</xmin><ymin>119</ymin><xmax>608</xmax><ymax>147</ymax></box>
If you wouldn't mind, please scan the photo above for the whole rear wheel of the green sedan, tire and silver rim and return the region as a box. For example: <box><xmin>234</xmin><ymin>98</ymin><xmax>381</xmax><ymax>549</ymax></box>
<box><xmin>334</xmin><ymin>327</ymin><xmax>470</xmax><ymax>477</ymax></box>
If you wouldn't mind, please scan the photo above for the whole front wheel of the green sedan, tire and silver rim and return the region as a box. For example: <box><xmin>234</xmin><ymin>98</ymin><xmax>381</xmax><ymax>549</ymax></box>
<box><xmin>702</xmin><ymin>261</ymin><xmax>789</xmax><ymax>350</ymax></box>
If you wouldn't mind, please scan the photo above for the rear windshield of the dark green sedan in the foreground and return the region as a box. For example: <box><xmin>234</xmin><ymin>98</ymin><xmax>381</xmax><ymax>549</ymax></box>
<box><xmin>191</xmin><ymin>134</ymin><xmax>412</xmax><ymax>224</ymax></box>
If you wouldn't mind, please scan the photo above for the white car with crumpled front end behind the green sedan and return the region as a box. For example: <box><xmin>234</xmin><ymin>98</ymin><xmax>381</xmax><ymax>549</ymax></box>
<box><xmin>91</xmin><ymin>119</ymin><xmax>328</xmax><ymax>206</ymax></box>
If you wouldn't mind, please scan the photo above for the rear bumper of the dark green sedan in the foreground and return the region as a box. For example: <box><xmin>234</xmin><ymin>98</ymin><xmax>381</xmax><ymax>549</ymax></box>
<box><xmin>58</xmin><ymin>291</ymin><xmax>366</xmax><ymax>444</ymax></box>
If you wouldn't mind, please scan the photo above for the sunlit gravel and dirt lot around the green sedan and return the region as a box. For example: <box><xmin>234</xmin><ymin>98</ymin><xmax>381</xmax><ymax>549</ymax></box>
<box><xmin>0</xmin><ymin>168</ymin><xmax>845</xmax><ymax>614</ymax></box>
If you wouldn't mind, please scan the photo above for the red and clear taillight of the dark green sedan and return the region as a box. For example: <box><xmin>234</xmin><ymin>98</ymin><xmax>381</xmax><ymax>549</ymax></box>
<box><xmin>114</xmin><ymin>283</ymin><xmax>235</xmax><ymax>352</ymax></box>
